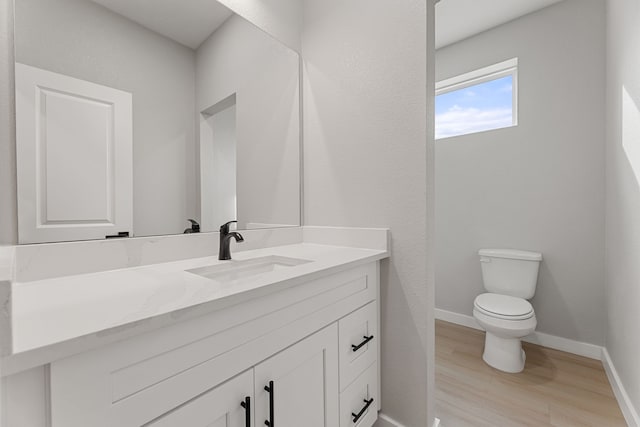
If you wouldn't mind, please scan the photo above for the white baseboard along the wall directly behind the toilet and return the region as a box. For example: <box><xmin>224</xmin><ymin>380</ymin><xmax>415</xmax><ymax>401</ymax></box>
<box><xmin>435</xmin><ymin>308</ymin><xmax>603</xmax><ymax>360</ymax></box>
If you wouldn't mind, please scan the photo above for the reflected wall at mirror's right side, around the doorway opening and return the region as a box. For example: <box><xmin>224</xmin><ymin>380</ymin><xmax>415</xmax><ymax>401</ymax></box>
<box><xmin>196</xmin><ymin>15</ymin><xmax>300</xmax><ymax>229</ymax></box>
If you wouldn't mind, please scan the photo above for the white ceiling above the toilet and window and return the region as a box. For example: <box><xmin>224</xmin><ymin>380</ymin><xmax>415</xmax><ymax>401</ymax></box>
<box><xmin>436</xmin><ymin>0</ymin><xmax>562</xmax><ymax>49</ymax></box>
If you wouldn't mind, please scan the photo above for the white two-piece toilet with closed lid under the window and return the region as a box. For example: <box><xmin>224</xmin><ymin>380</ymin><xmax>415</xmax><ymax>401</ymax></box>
<box><xmin>473</xmin><ymin>249</ymin><xmax>542</xmax><ymax>373</ymax></box>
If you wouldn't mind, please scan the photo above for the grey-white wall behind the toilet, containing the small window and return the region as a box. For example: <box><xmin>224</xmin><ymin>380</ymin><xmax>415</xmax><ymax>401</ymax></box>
<box><xmin>436</xmin><ymin>0</ymin><xmax>606</xmax><ymax>345</ymax></box>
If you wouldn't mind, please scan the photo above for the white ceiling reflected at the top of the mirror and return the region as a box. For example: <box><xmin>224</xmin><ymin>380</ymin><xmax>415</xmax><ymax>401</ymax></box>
<box><xmin>92</xmin><ymin>0</ymin><xmax>233</xmax><ymax>49</ymax></box>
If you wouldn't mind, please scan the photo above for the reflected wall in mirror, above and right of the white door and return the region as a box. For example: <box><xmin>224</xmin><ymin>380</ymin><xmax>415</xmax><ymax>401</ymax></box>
<box><xmin>15</xmin><ymin>0</ymin><xmax>196</xmax><ymax>236</ymax></box>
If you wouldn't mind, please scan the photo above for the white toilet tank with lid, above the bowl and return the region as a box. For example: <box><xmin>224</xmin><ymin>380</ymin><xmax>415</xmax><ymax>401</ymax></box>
<box><xmin>478</xmin><ymin>249</ymin><xmax>542</xmax><ymax>299</ymax></box>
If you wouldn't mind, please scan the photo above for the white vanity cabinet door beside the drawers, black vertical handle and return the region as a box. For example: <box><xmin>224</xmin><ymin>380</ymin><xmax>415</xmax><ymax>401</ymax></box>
<box><xmin>255</xmin><ymin>324</ymin><xmax>339</xmax><ymax>427</ymax></box>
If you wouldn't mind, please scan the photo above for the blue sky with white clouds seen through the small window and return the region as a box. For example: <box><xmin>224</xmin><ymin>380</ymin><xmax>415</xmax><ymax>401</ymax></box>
<box><xmin>436</xmin><ymin>75</ymin><xmax>513</xmax><ymax>139</ymax></box>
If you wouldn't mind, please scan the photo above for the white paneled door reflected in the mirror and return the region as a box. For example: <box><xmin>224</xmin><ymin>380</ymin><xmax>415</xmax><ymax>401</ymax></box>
<box><xmin>16</xmin><ymin>64</ymin><xmax>133</xmax><ymax>243</ymax></box>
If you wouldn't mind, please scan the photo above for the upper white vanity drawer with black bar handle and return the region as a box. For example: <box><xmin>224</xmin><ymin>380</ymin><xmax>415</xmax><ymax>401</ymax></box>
<box><xmin>338</xmin><ymin>301</ymin><xmax>379</xmax><ymax>390</ymax></box>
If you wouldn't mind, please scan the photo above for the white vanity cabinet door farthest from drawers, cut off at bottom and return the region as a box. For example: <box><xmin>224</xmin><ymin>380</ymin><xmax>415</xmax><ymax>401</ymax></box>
<box><xmin>145</xmin><ymin>370</ymin><xmax>253</xmax><ymax>427</ymax></box>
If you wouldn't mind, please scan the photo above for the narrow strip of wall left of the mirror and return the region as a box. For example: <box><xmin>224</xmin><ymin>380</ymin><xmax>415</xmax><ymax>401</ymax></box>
<box><xmin>0</xmin><ymin>0</ymin><xmax>18</xmax><ymax>245</ymax></box>
